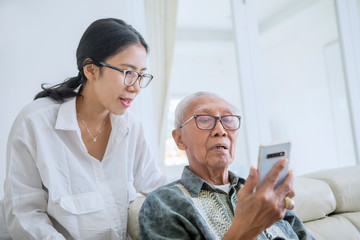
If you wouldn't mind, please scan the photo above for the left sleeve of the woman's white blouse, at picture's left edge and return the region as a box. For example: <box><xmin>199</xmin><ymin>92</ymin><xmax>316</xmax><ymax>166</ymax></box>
<box><xmin>4</xmin><ymin>117</ymin><xmax>65</xmax><ymax>240</ymax></box>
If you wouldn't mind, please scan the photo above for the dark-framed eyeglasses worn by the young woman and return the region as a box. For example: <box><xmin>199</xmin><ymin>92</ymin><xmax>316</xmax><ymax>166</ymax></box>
<box><xmin>96</xmin><ymin>62</ymin><xmax>153</xmax><ymax>88</ymax></box>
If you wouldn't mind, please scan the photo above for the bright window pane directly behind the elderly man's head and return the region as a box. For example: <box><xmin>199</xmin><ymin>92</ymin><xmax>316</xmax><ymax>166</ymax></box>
<box><xmin>162</xmin><ymin>0</ymin><xmax>246</xmax><ymax>176</ymax></box>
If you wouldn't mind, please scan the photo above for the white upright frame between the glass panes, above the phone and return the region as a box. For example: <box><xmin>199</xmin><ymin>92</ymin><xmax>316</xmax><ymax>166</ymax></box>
<box><xmin>231</xmin><ymin>0</ymin><xmax>270</xmax><ymax>166</ymax></box>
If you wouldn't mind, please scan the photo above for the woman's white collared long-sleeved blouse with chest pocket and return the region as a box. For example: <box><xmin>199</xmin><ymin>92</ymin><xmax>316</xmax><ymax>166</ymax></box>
<box><xmin>4</xmin><ymin>98</ymin><xmax>167</xmax><ymax>240</ymax></box>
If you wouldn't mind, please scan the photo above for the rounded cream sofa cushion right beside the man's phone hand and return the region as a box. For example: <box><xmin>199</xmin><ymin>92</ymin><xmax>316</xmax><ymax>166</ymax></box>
<box><xmin>294</xmin><ymin>177</ymin><xmax>336</xmax><ymax>222</ymax></box>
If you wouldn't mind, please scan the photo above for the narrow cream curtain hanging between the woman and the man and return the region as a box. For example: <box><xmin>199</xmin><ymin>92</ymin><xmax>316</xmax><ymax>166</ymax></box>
<box><xmin>144</xmin><ymin>0</ymin><xmax>178</xmax><ymax>163</ymax></box>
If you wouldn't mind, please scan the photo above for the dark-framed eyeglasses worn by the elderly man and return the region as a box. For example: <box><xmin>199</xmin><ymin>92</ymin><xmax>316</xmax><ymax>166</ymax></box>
<box><xmin>180</xmin><ymin>115</ymin><xmax>241</xmax><ymax>130</ymax></box>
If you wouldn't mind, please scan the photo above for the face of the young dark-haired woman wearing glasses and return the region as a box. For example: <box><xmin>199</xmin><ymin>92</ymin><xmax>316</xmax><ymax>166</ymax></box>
<box><xmin>94</xmin><ymin>44</ymin><xmax>147</xmax><ymax>115</ymax></box>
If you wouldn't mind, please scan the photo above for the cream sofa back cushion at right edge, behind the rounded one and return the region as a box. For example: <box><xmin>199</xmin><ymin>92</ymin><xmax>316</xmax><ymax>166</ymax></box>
<box><xmin>304</xmin><ymin>166</ymin><xmax>360</xmax><ymax>213</ymax></box>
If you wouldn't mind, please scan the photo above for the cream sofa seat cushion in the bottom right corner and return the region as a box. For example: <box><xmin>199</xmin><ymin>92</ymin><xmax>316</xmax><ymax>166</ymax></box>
<box><xmin>305</xmin><ymin>214</ymin><xmax>360</xmax><ymax>240</ymax></box>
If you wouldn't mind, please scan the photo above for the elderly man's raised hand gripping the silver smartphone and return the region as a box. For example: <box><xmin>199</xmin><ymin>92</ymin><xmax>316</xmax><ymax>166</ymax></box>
<box><xmin>228</xmin><ymin>159</ymin><xmax>295</xmax><ymax>239</ymax></box>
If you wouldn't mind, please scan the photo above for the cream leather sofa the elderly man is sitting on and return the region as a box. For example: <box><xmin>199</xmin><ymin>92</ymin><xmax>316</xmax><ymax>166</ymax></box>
<box><xmin>128</xmin><ymin>166</ymin><xmax>360</xmax><ymax>240</ymax></box>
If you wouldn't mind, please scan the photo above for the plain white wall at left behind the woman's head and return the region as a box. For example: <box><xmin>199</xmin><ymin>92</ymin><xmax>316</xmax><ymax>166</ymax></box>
<box><xmin>0</xmin><ymin>0</ymin><xmax>152</xmax><ymax>198</ymax></box>
